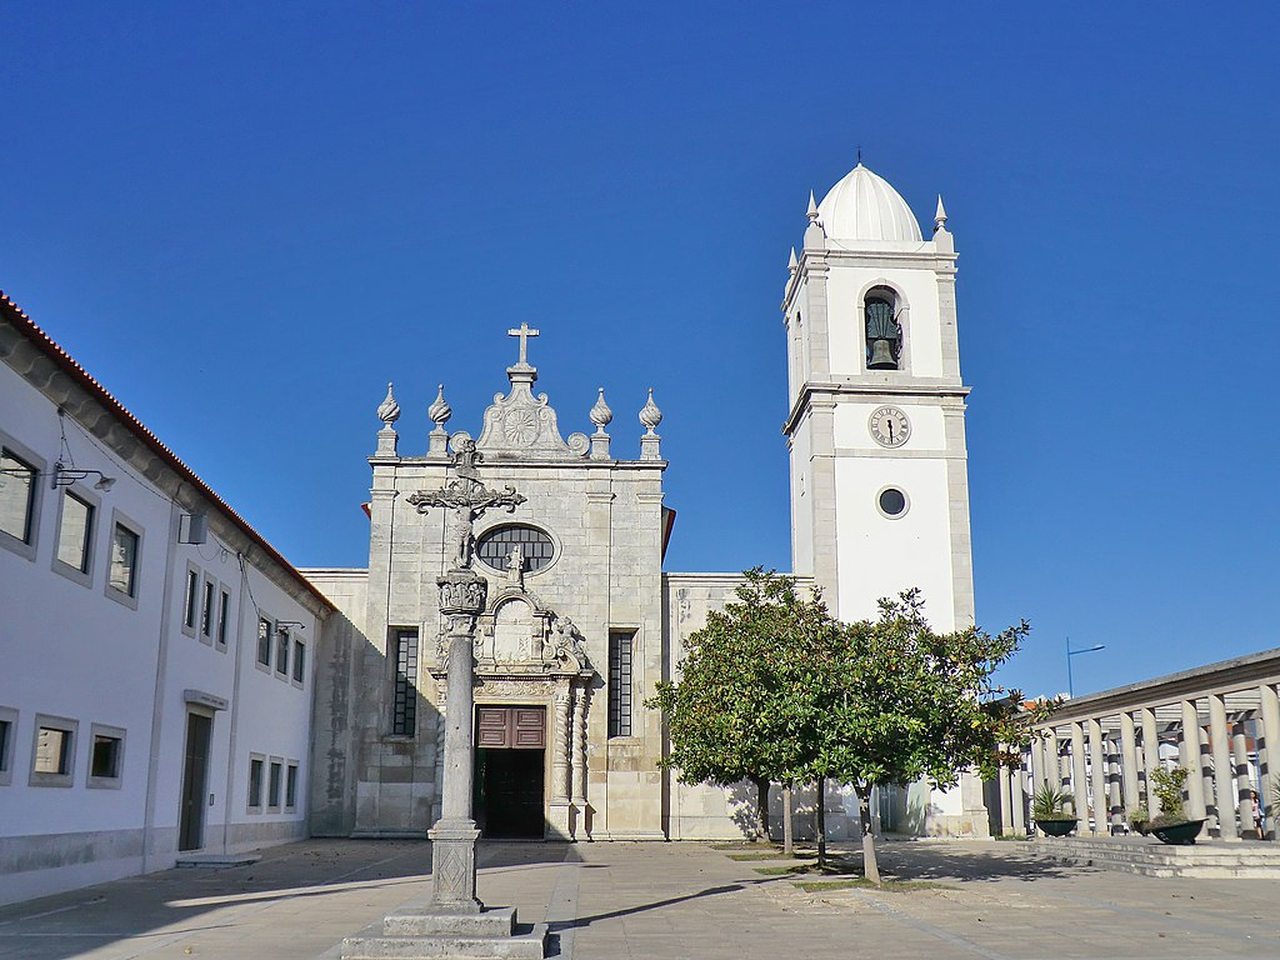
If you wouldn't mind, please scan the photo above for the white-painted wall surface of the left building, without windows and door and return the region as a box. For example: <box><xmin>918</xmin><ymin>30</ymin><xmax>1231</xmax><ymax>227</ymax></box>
<box><xmin>0</xmin><ymin>364</ymin><xmax>319</xmax><ymax>902</ymax></box>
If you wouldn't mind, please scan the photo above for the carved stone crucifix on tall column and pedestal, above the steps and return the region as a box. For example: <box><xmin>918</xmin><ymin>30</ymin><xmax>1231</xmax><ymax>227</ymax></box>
<box><xmin>408</xmin><ymin>440</ymin><xmax>525</xmax><ymax>914</ymax></box>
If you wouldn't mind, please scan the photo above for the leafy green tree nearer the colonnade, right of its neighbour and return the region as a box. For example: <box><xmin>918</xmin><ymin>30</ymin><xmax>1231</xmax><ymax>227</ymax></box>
<box><xmin>809</xmin><ymin>590</ymin><xmax>1030</xmax><ymax>883</ymax></box>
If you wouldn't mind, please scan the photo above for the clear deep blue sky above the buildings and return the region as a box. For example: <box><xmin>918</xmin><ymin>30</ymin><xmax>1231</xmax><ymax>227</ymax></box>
<box><xmin>0</xmin><ymin>3</ymin><xmax>1280</xmax><ymax>692</ymax></box>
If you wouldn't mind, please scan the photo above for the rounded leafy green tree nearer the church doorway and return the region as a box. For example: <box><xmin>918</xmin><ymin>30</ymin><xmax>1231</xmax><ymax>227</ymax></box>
<box><xmin>646</xmin><ymin>567</ymin><xmax>840</xmax><ymax>840</ymax></box>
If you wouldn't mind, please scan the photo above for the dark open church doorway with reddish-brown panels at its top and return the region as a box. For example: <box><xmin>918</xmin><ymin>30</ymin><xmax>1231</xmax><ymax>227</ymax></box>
<box><xmin>475</xmin><ymin>707</ymin><xmax>547</xmax><ymax>838</ymax></box>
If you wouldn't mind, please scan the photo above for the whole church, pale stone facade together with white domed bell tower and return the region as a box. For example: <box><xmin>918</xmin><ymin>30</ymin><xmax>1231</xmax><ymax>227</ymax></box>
<box><xmin>305</xmin><ymin>164</ymin><xmax>987</xmax><ymax>840</ymax></box>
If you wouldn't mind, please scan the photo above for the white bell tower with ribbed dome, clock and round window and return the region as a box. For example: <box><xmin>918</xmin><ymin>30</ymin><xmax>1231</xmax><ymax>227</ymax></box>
<box><xmin>782</xmin><ymin>161</ymin><xmax>974</xmax><ymax>631</ymax></box>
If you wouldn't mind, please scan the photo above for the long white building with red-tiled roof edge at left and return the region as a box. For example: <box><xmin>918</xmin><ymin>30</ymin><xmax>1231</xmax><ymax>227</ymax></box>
<box><xmin>0</xmin><ymin>294</ymin><xmax>330</xmax><ymax>902</ymax></box>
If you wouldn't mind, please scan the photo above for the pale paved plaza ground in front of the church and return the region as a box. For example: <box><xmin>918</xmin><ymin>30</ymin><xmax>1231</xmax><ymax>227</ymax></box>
<box><xmin>0</xmin><ymin>840</ymin><xmax>1280</xmax><ymax>960</ymax></box>
